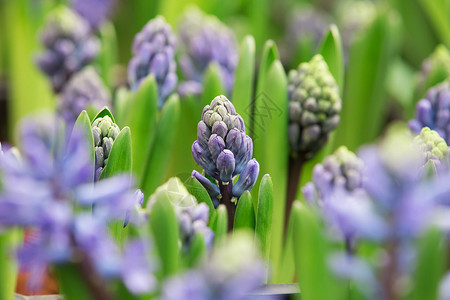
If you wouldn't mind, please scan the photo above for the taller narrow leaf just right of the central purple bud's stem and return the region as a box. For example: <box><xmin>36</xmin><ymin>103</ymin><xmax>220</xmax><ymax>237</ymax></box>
<box><xmin>255</xmin><ymin>174</ymin><xmax>273</xmax><ymax>268</ymax></box>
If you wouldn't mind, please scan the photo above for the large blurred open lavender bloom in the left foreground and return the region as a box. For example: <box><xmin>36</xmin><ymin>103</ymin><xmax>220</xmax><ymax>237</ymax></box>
<box><xmin>0</xmin><ymin>116</ymin><xmax>156</xmax><ymax>292</ymax></box>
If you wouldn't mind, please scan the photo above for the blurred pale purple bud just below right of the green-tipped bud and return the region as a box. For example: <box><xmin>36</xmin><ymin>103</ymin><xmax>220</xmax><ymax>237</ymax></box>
<box><xmin>302</xmin><ymin>146</ymin><xmax>364</xmax><ymax>204</ymax></box>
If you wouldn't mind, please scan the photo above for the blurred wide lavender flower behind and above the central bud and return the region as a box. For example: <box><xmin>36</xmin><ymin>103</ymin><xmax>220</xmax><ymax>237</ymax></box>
<box><xmin>179</xmin><ymin>9</ymin><xmax>238</xmax><ymax>95</ymax></box>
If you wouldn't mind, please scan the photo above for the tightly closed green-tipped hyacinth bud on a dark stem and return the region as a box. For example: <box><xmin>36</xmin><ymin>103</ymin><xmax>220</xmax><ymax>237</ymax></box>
<box><xmin>288</xmin><ymin>55</ymin><xmax>342</xmax><ymax>159</ymax></box>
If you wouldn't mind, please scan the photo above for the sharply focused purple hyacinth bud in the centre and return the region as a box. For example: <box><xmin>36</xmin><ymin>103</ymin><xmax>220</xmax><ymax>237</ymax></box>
<box><xmin>192</xmin><ymin>95</ymin><xmax>259</xmax><ymax>197</ymax></box>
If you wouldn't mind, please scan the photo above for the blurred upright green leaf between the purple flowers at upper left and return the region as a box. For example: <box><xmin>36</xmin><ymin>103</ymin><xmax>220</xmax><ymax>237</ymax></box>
<box><xmin>98</xmin><ymin>22</ymin><xmax>118</xmax><ymax>86</ymax></box>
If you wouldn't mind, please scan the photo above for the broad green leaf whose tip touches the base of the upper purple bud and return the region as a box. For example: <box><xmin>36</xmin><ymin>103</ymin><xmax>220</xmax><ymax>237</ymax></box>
<box><xmin>125</xmin><ymin>75</ymin><xmax>158</xmax><ymax>181</ymax></box>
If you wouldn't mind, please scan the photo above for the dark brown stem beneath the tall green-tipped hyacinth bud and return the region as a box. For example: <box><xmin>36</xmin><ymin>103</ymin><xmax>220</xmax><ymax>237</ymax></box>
<box><xmin>284</xmin><ymin>155</ymin><xmax>304</xmax><ymax>235</ymax></box>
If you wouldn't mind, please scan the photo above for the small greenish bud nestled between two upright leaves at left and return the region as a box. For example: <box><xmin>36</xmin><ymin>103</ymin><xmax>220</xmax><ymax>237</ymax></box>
<box><xmin>92</xmin><ymin>116</ymin><xmax>120</xmax><ymax>180</ymax></box>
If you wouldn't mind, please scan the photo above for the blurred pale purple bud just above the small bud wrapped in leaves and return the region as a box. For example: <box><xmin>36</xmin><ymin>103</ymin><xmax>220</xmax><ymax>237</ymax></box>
<box><xmin>58</xmin><ymin>67</ymin><xmax>111</xmax><ymax>124</ymax></box>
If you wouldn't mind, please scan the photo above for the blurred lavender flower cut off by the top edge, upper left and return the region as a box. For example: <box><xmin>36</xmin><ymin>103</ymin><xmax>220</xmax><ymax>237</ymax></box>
<box><xmin>71</xmin><ymin>0</ymin><xmax>116</xmax><ymax>30</ymax></box>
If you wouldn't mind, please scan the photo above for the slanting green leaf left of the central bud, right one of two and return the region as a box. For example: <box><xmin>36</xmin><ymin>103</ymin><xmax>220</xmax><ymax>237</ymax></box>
<box><xmin>141</xmin><ymin>94</ymin><xmax>180</xmax><ymax>195</ymax></box>
